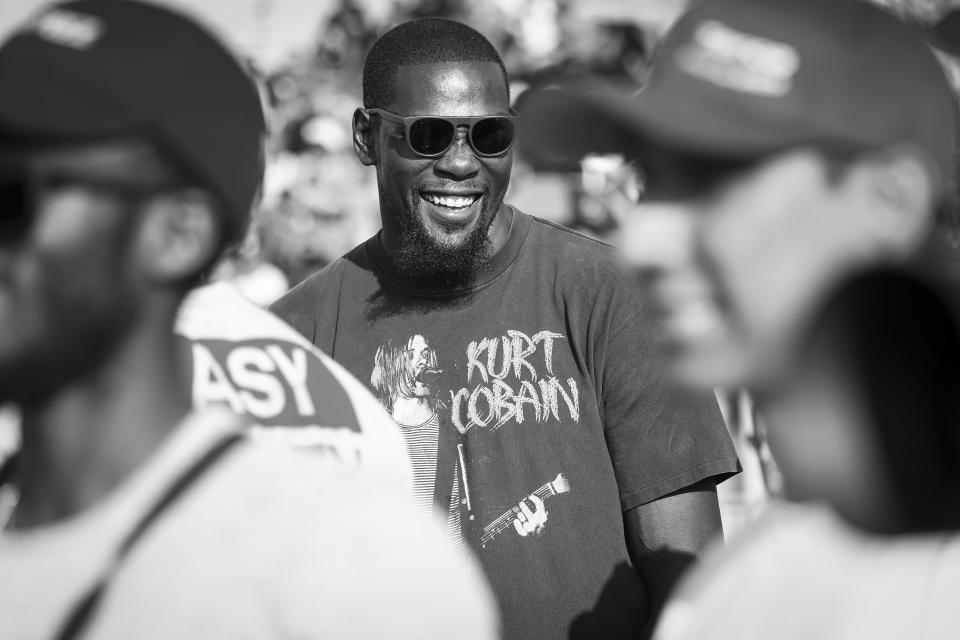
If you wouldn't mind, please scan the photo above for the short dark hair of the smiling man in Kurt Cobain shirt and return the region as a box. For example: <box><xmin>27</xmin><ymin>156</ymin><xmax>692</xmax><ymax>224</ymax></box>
<box><xmin>363</xmin><ymin>18</ymin><xmax>510</xmax><ymax>109</ymax></box>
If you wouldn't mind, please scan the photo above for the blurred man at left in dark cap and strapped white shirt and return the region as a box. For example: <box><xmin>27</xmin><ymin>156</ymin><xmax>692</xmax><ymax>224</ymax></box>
<box><xmin>0</xmin><ymin>0</ymin><xmax>496</xmax><ymax>638</ymax></box>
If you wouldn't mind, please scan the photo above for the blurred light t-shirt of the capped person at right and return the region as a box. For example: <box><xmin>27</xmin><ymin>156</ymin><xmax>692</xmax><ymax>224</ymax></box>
<box><xmin>654</xmin><ymin>504</ymin><xmax>960</xmax><ymax>640</ymax></box>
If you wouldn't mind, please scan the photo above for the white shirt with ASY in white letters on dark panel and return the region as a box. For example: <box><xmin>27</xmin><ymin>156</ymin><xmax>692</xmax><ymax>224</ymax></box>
<box><xmin>175</xmin><ymin>282</ymin><xmax>412</xmax><ymax>487</ymax></box>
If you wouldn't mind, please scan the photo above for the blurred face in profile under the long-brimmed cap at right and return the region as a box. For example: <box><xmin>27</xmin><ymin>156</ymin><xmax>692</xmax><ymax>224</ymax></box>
<box><xmin>624</xmin><ymin>149</ymin><xmax>869</xmax><ymax>388</ymax></box>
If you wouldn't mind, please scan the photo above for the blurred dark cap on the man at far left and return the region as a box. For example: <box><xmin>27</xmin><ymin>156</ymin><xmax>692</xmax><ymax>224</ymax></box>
<box><xmin>0</xmin><ymin>0</ymin><xmax>265</xmax><ymax>241</ymax></box>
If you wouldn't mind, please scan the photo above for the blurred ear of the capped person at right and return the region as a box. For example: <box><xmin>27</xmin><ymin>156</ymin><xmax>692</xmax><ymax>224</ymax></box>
<box><xmin>850</xmin><ymin>146</ymin><xmax>939</xmax><ymax>257</ymax></box>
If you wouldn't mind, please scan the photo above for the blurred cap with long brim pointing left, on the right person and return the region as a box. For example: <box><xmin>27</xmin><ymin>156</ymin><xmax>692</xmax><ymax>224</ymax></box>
<box><xmin>528</xmin><ymin>0</ymin><xmax>957</xmax><ymax>195</ymax></box>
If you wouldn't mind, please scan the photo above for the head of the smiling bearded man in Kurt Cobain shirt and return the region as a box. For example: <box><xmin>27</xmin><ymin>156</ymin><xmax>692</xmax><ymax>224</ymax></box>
<box><xmin>353</xmin><ymin>18</ymin><xmax>513</xmax><ymax>279</ymax></box>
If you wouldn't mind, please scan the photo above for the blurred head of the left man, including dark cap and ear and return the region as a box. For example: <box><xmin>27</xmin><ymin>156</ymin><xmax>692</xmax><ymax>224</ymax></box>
<box><xmin>0</xmin><ymin>1</ymin><xmax>263</xmax><ymax>403</ymax></box>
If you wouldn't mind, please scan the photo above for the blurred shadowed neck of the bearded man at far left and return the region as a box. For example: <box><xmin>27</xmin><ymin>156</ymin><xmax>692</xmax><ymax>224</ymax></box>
<box><xmin>15</xmin><ymin>322</ymin><xmax>190</xmax><ymax>529</ymax></box>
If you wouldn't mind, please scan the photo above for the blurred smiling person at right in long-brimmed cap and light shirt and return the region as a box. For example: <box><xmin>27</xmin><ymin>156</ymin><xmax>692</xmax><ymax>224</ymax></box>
<box><xmin>535</xmin><ymin>0</ymin><xmax>960</xmax><ymax>638</ymax></box>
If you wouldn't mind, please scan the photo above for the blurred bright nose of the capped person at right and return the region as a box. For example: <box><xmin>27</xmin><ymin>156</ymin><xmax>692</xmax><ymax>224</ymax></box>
<box><xmin>622</xmin><ymin>202</ymin><xmax>696</xmax><ymax>271</ymax></box>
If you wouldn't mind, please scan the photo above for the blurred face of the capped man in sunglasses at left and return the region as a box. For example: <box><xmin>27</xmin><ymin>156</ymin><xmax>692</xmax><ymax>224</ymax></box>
<box><xmin>0</xmin><ymin>146</ymin><xmax>148</xmax><ymax>404</ymax></box>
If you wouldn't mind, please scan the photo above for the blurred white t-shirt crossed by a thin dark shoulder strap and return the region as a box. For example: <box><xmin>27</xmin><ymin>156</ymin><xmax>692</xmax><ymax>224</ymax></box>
<box><xmin>0</xmin><ymin>409</ymin><xmax>498</xmax><ymax>639</ymax></box>
